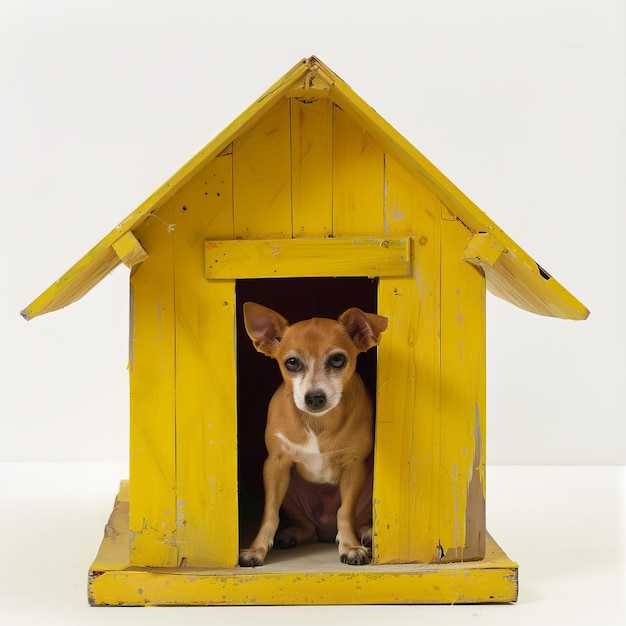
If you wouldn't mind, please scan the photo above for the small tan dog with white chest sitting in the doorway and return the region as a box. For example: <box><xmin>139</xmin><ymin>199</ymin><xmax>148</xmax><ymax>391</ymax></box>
<box><xmin>239</xmin><ymin>302</ymin><xmax>388</xmax><ymax>567</ymax></box>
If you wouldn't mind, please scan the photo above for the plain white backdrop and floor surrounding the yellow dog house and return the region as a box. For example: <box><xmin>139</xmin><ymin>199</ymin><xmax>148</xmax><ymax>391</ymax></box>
<box><xmin>0</xmin><ymin>0</ymin><xmax>626</xmax><ymax>625</ymax></box>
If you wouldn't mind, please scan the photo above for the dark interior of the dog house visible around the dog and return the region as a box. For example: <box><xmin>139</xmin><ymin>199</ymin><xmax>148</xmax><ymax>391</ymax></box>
<box><xmin>237</xmin><ymin>278</ymin><xmax>378</xmax><ymax>543</ymax></box>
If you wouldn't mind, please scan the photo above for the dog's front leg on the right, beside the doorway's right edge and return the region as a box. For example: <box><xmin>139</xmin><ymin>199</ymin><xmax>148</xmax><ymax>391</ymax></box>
<box><xmin>337</xmin><ymin>461</ymin><xmax>372</xmax><ymax>565</ymax></box>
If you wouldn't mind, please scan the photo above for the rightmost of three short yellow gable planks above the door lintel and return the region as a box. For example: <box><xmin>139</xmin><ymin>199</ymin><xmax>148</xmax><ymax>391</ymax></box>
<box><xmin>333</xmin><ymin>106</ymin><xmax>384</xmax><ymax>237</ymax></box>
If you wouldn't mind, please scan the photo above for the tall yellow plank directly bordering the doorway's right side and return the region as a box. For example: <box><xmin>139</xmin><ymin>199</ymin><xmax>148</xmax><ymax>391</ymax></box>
<box><xmin>374</xmin><ymin>157</ymin><xmax>441</xmax><ymax>563</ymax></box>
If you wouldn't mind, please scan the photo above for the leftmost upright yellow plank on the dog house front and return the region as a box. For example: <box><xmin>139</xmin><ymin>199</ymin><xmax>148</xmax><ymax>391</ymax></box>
<box><xmin>129</xmin><ymin>202</ymin><xmax>178</xmax><ymax>567</ymax></box>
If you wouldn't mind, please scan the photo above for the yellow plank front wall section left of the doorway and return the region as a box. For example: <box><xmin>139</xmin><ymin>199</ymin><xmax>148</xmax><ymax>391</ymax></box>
<box><xmin>130</xmin><ymin>149</ymin><xmax>238</xmax><ymax>567</ymax></box>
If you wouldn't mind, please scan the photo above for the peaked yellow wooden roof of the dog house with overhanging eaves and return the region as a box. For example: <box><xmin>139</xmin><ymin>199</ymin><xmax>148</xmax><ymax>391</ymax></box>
<box><xmin>22</xmin><ymin>57</ymin><xmax>589</xmax><ymax>320</ymax></box>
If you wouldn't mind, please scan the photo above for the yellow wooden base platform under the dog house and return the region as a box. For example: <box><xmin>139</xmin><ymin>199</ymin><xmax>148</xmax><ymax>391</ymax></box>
<box><xmin>89</xmin><ymin>481</ymin><xmax>518</xmax><ymax>606</ymax></box>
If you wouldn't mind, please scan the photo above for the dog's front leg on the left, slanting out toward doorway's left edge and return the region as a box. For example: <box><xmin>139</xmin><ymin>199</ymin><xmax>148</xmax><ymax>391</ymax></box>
<box><xmin>239</xmin><ymin>454</ymin><xmax>292</xmax><ymax>567</ymax></box>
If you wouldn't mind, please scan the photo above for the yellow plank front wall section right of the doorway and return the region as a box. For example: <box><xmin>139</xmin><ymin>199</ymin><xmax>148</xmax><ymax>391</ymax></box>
<box><xmin>374</xmin><ymin>156</ymin><xmax>485</xmax><ymax>563</ymax></box>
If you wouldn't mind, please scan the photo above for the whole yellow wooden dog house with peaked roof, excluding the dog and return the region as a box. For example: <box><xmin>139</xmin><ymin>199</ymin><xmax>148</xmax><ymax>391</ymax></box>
<box><xmin>22</xmin><ymin>57</ymin><xmax>588</xmax><ymax>605</ymax></box>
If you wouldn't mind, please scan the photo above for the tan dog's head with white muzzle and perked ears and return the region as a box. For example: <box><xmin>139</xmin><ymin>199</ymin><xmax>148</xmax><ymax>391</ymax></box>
<box><xmin>243</xmin><ymin>302</ymin><xmax>388</xmax><ymax>415</ymax></box>
